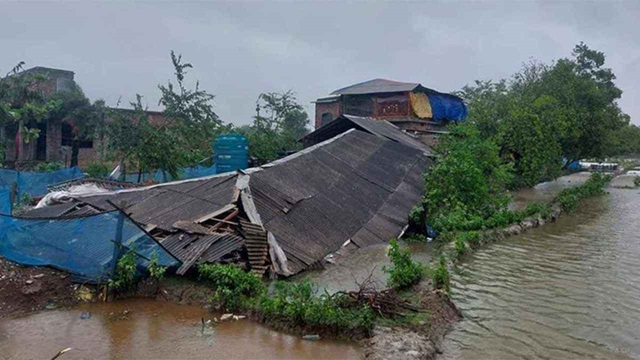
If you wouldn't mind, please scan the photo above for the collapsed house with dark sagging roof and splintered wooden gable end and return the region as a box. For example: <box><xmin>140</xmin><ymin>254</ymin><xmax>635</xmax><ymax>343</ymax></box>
<box><xmin>27</xmin><ymin>128</ymin><xmax>431</xmax><ymax>276</ymax></box>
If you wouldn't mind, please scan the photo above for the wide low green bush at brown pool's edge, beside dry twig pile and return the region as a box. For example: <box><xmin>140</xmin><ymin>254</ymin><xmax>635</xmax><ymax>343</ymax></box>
<box><xmin>256</xmin><ymin>281</ymin><xmax>374</xmax><ymax>332</ymax></box>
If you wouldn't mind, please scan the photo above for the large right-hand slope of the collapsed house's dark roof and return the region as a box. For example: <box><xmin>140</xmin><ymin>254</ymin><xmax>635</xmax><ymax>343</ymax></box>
<box><xmin>249</xmin><ymin>131</ymin><xmax>430</xmax><ymax>273</ymax></box>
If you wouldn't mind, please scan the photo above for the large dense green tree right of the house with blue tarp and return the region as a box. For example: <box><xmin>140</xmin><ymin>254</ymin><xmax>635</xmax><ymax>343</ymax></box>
<box><xmin>460</xmin><ymin>43</ymin><xmax>629</xmax><ymax>187</ymax></box>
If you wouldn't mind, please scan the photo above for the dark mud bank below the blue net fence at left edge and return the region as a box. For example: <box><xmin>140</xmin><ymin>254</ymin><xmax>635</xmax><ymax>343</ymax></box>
<box><xmin>0</xmin><ymin>257</ymin><xmax>77</xmax><ymax>318</ymax></box>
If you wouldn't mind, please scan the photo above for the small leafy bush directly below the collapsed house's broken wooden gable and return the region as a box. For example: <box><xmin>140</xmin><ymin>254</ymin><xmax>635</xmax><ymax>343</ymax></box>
<box><xmin>198</xmin><ymin>264</ymin><xmax>266</xmax><ymax>311</ymax></box>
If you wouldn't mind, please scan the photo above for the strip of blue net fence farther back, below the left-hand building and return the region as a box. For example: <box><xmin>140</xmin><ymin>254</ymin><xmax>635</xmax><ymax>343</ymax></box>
<box><xmin>0</xmin><ymin>166</ymin><xmax>84</xmax><ymax>198</ymax></box>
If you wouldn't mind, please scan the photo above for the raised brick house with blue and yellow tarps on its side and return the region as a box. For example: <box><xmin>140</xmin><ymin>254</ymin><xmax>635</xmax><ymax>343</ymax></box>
<box><xmin>315</xmin><ymin>79</ymin><xmax>467</xmax><ymax>145</ymax></box>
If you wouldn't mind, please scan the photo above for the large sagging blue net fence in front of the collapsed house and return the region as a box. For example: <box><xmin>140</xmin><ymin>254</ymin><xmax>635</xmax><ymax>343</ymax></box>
<box><xmin>0</xmin><ymin>211</ymin><xmax>179</xmax><ymax>283</ymax></box>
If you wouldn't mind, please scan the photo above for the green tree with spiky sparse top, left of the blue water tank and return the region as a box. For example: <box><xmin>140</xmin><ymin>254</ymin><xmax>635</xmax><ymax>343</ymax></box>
<box><xmin>108</xmin><ymin>51</ymin><xmax>231</xmax><ymax>179</ymax></box>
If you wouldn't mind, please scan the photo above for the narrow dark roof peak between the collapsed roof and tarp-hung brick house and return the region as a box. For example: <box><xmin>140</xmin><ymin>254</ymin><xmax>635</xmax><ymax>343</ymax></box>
<box><xmin>300</xmin><ymin>115</ymin><xmax>432</xmax><ymax>155</ymax></box>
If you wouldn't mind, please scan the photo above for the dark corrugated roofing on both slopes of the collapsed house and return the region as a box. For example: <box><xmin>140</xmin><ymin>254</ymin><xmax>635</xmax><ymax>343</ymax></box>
<box><xmin>27</xmin><ymin>129</ymin><xmax>430</xmax><ymax>273</ymax></box>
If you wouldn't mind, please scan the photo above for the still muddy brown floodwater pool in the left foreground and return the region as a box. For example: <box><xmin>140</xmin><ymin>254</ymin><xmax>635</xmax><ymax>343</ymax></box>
<box><xmin>0</xmin><ymin>299</ymin><xmax>362</xmax><ymax>360</ymax></box>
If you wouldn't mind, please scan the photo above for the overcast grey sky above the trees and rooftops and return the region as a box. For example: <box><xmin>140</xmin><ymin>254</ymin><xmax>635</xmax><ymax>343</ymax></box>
<box><xmin>0</xmin><ymin>0</ymin><xmax>640</xmax><ymax>124</ymax></box>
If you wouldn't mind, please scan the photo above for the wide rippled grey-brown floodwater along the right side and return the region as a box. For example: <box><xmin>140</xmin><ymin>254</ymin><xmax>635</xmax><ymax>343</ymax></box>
<box><xmin>441</xmin><ymin>184</ymin><xmax>640</xmax><ymax>359</ymax></box>
